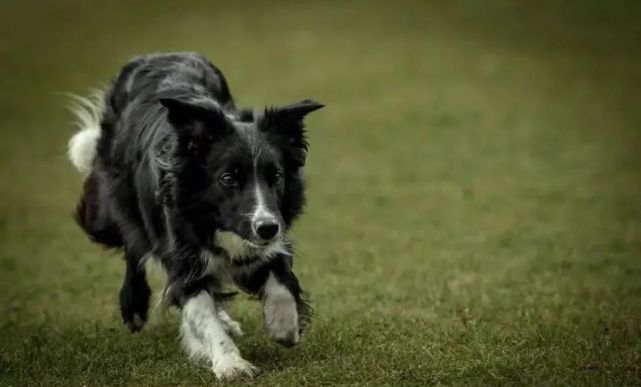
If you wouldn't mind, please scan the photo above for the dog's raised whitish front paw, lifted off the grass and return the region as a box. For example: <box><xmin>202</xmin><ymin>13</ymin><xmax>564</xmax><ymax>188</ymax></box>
<box><xmin>265</xmin><ymin>300</ymin><xmax>300</xmax><ymax>347</ymax></box>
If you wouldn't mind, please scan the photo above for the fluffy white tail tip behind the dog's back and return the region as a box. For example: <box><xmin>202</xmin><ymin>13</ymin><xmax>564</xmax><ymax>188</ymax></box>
<box><xmin>68</xmin><ymin>89</ymin><xmax>105</xmax><ymax>173</ymax></box>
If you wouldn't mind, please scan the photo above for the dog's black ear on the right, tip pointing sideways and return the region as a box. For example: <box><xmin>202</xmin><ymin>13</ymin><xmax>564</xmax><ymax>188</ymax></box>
<box><xmin>259</xmin><ymin>99</ymin><xmax>325</xmax><ymax>167</ymax></box>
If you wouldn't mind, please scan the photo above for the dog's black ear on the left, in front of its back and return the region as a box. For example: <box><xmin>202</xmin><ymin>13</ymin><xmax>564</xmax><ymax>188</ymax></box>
<box><xmin>159</xmin><ymin>95</ymin><xmax>231</xmax><ymax>142</ymax></box>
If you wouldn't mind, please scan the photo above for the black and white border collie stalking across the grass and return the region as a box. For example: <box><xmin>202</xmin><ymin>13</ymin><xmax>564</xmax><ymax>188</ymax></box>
<box><xmin>69</xmin><ymin>53</ymin><xmax>323</xmax><ymax>379</ymax></box>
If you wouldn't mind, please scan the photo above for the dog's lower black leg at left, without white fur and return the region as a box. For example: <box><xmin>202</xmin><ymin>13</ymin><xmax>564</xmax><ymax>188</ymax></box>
<box><xmin>120</xmin><ymin>249</ymin><xmax>151</xmax><ymax>332</ymax></box>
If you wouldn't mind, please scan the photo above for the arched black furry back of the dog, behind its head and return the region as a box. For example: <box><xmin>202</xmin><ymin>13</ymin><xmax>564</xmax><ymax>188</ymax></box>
<box><xmin>97</xmin><ymin>53</ymin><xmax>235</xmax><ymax>164</ymax></box>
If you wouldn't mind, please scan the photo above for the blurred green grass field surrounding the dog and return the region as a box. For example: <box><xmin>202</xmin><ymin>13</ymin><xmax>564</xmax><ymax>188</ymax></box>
<box><xmin>0</xmin><ymin>0</ymin><xmax>641</xmax><ymax>386</ymax></box>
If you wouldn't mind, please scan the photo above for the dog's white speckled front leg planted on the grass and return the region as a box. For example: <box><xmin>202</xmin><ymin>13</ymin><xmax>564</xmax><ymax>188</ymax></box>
<box><xmin>181</xmin><ymin>290</ymin><xmax>258</xmax><ymax>380</ymax></box>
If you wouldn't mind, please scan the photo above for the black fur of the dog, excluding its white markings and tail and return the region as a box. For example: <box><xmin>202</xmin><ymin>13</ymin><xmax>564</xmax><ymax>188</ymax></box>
<box><xmin>76</xmin><ymin>53</ymin><xmax>322</xmax><ymax>330</ymax></box>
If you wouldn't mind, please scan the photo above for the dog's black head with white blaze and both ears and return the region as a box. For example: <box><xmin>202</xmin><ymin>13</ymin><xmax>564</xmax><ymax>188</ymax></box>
<box><xmin>160</xmin><ymin>95</ymin><xmax>323</xmax><ymax>258</ymax></box>
